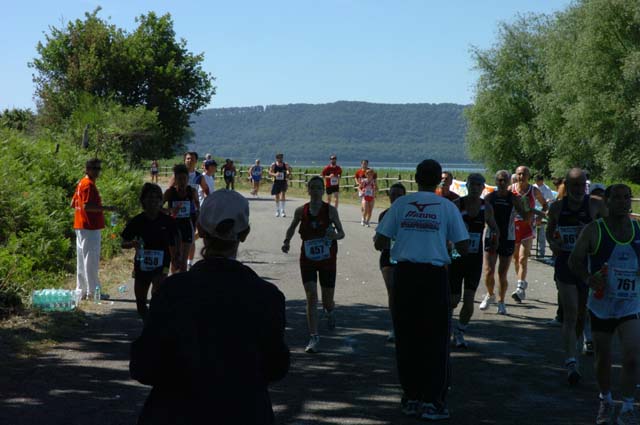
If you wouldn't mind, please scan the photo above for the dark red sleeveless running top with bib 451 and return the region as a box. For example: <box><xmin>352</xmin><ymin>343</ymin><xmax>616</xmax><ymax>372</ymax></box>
<box><xmin>298</xmin><ymin>202</ymin><xmax>338</xmax><ymax>270</ymax></box>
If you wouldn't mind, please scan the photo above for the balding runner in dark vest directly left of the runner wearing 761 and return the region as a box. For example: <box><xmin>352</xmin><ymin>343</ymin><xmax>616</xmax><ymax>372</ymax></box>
<box><xmin>547</xmin><ymin>168</ymin><xmax>603</xmax><ymax>385</ymax></box>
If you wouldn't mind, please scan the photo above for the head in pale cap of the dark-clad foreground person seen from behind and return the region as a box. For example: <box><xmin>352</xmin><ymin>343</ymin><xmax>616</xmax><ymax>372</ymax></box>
<box><xmin>197</xmin><ymin>189</ymin><xmax>250</xmax><ymax>260</ymax></box>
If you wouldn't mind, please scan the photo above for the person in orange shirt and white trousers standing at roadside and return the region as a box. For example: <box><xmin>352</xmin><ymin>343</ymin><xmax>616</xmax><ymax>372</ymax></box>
<box><xmin>71</xmin><ymin>158</ymin><xmax>116</xmax><ymax>299</ymax></box>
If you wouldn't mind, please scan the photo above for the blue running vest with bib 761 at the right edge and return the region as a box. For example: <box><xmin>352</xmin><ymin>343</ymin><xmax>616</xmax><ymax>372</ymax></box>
<box><xmin>587</xmin><ymin>219</ymin><xmax>640</xmax><ymax>319</ymax></box>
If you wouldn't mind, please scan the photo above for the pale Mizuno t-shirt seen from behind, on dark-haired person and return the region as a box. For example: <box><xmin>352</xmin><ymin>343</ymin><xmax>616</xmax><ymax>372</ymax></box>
<box><xmin>376</xmin><ymin>192</ymin><xmax>469</xmax><ymax>266</ymax></box>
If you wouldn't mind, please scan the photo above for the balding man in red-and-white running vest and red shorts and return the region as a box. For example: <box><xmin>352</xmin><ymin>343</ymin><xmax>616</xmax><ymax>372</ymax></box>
<box><xmin>511</xmin><ymin>165</ymin><xmax>548</xmax><ymax>303</ymax></box>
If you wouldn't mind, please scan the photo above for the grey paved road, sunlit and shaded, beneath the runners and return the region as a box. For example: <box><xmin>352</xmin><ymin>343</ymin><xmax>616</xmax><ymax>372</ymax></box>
<box><xmin>0</xmin><ymin>193</ymin><xmax>619</xmax><ymax>425</ymax></box>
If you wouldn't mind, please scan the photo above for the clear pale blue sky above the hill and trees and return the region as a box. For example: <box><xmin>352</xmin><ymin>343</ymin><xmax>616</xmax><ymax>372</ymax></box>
<box><xmin>0</xmin><ymin>0</ymin><xmax>569</xmax><ymax>109</ymax></box>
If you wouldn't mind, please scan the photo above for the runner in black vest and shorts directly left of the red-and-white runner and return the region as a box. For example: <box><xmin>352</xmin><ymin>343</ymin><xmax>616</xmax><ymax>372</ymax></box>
<box><xmin>480</xmin><ymin>170</ymin><xmax>524</xmax><ymax>315</ymax></box>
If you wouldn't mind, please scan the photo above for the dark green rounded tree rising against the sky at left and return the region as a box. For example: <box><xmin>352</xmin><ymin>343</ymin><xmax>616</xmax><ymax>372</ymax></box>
<box><xmin>30</xmin><ymin>8</ymin><xmax>215</xmax><ymax>155</ymax></box>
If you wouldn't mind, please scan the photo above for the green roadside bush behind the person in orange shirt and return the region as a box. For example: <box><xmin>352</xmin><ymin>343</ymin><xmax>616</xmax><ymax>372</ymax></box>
<box><xmin>0</xmin><ymin>129</ymin><xmax>142</xmax><ymax>310</ymax></box>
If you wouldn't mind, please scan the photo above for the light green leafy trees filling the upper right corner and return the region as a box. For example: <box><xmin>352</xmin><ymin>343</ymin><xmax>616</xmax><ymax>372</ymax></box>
<box><xmin>466</xmin><ymin>0</ymin><xmax>640</xmax><ymax>182</ymax></box>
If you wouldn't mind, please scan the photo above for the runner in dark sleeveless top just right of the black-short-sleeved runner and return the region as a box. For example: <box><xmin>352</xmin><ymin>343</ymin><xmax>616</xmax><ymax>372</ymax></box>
<box><xmin>163</xmin><ymin>164</ymin><xmax>200</xmax><ymax>273</ymax></box>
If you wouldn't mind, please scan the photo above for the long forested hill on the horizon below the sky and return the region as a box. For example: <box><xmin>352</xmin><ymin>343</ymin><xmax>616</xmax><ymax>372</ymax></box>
<box><xmin>189</xmin><ymin>101</ymin><xmax>469</xmax><ymax>162</ymax></box>
